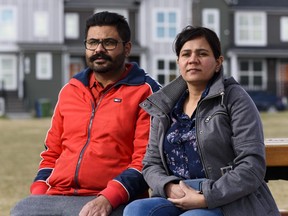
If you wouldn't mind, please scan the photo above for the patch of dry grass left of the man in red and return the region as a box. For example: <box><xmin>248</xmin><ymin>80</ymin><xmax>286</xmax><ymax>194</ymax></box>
<box><xmin>0</xmin><ymin>119</ymin><xmax>50</xmax><ymax>216</ymax></box>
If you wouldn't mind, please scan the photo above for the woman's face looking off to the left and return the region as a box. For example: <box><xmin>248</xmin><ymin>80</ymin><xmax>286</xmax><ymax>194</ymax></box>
<box><xmin>177</xmin><ymin>37</ymin><xmax>223</xmax><ymax>89</ymax></box>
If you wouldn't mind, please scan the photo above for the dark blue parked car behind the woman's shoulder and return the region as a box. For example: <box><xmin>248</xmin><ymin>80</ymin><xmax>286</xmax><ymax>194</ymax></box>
<box><xmin>247</xmin><ymin>91</ymin><xmax>287</xmax><ymax>111</ymax></box>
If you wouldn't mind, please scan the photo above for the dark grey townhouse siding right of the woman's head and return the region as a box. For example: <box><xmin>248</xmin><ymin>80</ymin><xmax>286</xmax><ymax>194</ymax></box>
<box><xmin>192</xmin><ymin>0</ymin><xmax>288</xmax><ymax>107</ymax></box>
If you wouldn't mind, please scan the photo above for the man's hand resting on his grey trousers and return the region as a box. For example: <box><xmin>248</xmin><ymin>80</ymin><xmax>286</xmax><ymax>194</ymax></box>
<box><xmin>79</xmin><ymin>195</ymin><xmax>112</xmax><ymax>216</ymax></box>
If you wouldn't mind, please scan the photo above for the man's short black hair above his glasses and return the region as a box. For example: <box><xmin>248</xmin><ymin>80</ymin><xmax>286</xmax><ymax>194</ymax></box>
<box><xmin>85</xmin><ymin>11</ymin><xmax>131</xmax><ymax>42</ymax></box>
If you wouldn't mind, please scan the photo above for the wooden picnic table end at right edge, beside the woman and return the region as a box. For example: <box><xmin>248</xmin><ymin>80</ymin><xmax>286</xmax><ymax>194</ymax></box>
<box><xmin>265</xmin><ymin>138</ymin><xmax>288</xmax><ymax>216</ymax></box>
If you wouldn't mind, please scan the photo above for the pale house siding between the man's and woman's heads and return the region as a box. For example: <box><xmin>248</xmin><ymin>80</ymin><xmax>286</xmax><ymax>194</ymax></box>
<box><xmin>138</xmin><ymin>0</ymin><xmax>192</xmax><ymax>84</ymax></box>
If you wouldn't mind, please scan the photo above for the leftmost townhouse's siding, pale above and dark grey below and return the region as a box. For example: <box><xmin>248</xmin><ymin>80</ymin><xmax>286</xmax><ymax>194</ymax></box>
<box><xmin>0</xmin><ymin>0</ymin><xmax>64</xmax><ymax>112</ymax></box>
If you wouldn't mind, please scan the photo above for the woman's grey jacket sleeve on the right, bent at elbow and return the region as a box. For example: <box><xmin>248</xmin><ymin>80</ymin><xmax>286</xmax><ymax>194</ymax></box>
<box><xmin>202</xmin><ymin>85</ymin><xmax>266</xmax><ymax>208</ymax></box>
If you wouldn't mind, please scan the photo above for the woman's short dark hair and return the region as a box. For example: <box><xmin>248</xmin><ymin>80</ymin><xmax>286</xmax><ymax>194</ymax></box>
<box><xmin>174</xmin><ymin>25</ymin><xmax>221</xmax><ymax>59</ymax></box>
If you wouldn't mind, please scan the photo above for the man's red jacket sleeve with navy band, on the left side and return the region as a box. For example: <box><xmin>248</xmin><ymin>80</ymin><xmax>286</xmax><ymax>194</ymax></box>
<box><xmin>30</xmin><ymin>93</ymin><xmax>63</xmax><ymax>194</ymax></box>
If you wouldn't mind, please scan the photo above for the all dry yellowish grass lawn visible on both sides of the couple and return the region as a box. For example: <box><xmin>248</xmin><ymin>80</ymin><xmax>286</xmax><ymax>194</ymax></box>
<box><xmin>0</xmin><ymin>112</ymin><xmax>288</xmax><ymax>216</ymax></box>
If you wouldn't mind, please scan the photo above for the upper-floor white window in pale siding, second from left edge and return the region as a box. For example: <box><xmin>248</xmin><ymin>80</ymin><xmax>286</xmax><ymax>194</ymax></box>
<box><xmin>33</xmin><ymin>11</ymin><xmax>49</xmax><ymax>38</ymax></box>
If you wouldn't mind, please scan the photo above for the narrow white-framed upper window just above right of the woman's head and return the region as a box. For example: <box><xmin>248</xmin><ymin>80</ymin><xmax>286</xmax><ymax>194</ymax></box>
<box><xmin>202</xmin><ymin>9</ymin><xmax>220</xmax><ymax>38</ymax></box>
